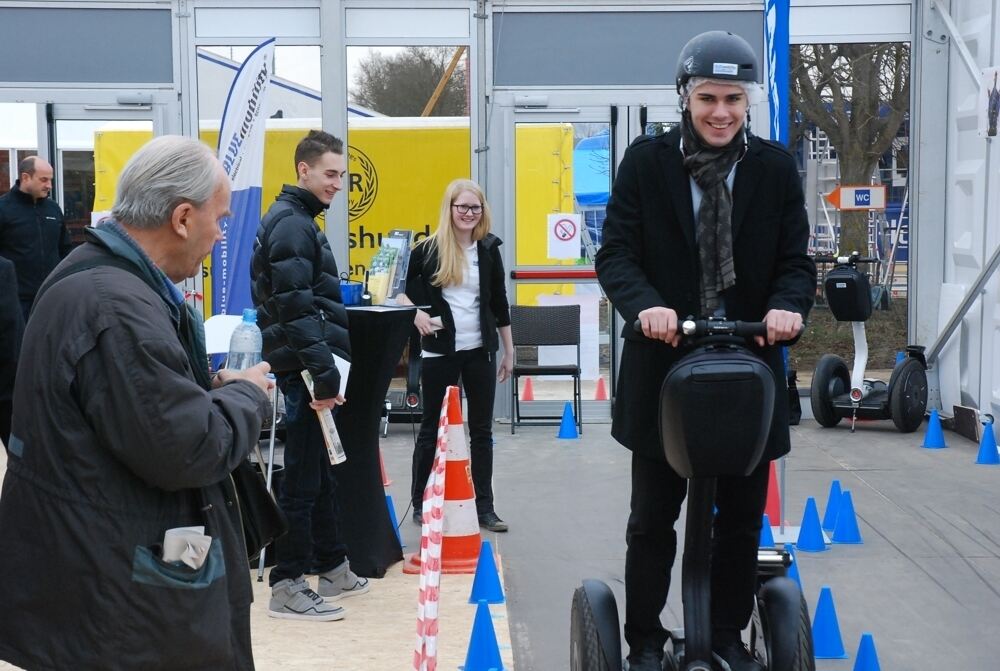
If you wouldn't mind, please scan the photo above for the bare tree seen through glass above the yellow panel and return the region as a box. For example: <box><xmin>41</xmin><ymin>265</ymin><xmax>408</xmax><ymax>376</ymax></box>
<box><xmin>350</xmin><ymin>47</ymin><xmax>469</xmax><ymax>116</ymax></box>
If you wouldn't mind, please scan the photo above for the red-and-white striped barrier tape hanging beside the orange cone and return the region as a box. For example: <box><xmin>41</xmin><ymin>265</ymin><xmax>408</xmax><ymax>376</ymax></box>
<box><xmin>403</xmin><ymin>387</ymin><xmax>458</xmax><ymax>671</ymax></box>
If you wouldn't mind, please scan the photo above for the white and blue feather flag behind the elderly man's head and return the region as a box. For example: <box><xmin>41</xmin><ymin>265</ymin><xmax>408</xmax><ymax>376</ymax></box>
<box><xmin>212</xmin><ymin>38</ymin><xmax>274</xmax><ymax>315</ymax></box>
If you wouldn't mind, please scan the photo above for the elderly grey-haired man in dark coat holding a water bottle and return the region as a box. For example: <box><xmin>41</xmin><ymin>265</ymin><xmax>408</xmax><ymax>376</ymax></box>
<box><xmin>0</xmin><ymin>136</ymin><xmax>270</xmax><ymax>671</ymax></box>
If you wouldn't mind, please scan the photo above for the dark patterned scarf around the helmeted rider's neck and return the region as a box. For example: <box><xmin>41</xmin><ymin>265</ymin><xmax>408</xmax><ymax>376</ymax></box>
<box><xmin>681</xmin><ymin>110</ymin><xmax>746</xmax><ymax>317</ymax></box>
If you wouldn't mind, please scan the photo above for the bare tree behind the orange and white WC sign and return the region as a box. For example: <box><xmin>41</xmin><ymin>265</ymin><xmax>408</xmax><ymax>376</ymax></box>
<box><xmin>791</xmin><ymin>42</ymin><xmax>910</xmax><ymax>253</ymax></box>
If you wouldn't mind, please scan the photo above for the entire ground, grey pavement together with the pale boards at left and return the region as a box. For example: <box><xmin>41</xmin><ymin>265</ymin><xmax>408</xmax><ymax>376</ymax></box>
<box><xmin>0</xmin><ymin>410</ymin><xmax>1000</xmax><ymax>671</ymax></box>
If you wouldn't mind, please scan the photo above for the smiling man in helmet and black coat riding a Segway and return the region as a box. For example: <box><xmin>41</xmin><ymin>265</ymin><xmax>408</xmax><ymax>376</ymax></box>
<box><xmin>596</xmin><ymin>31</ymin><xmax>816</xmax><ymax>671</ymax></box>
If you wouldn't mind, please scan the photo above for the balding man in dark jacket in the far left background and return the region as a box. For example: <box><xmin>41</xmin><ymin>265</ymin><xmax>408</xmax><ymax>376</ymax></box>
<box><xmin>0</xmin><ymin>156</ymin><xmax>73</xmax><ymax>321</ymax></box>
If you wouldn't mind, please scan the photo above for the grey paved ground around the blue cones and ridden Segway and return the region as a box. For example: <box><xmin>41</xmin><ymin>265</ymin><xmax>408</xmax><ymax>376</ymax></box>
<box><xmin>458</xmin><ymin>420</ymin><xmax>1000</xmax><ymax>671</ymax></box>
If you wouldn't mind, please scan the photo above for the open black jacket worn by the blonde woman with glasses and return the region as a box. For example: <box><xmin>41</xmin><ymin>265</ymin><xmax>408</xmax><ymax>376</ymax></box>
<box><xmin>406</xmin><ymin>233</ymin><xmax>510</xmax><ymax>354</ymax></box>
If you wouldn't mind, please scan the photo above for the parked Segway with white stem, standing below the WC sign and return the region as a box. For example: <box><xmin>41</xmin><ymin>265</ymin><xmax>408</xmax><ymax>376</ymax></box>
<box><xmin>809</xmin><ymin>252</ymin><xmax>927</xmax><ymax>433</ymax></box>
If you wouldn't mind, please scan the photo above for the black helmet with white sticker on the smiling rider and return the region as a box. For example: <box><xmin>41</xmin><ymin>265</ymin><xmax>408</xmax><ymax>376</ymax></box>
<box><xmin>677</xmin><ymin>30</ymin><xmax>758</xmax><ymax>95</ymax></box>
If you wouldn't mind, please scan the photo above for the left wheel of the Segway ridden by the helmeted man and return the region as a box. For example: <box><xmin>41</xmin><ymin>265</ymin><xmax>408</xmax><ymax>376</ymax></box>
<box><xmin>569</xmin><ymin>580</ymin><xmax>622</xmax><ymax>671</ymax></box>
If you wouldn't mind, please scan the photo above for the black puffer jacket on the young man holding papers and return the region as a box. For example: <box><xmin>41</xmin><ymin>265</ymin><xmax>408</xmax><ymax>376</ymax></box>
<box><xmin>250</xmin><ymin>184</ymin><xmax>351</xmax><ymax>399</ymax></box>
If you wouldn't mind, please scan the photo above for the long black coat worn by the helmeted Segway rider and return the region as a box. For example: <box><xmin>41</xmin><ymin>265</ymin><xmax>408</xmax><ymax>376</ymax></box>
<box><xmin>596</xmin><ymin>129</ymin><xmax>816</xmax><ymax>460</ymax></box>
